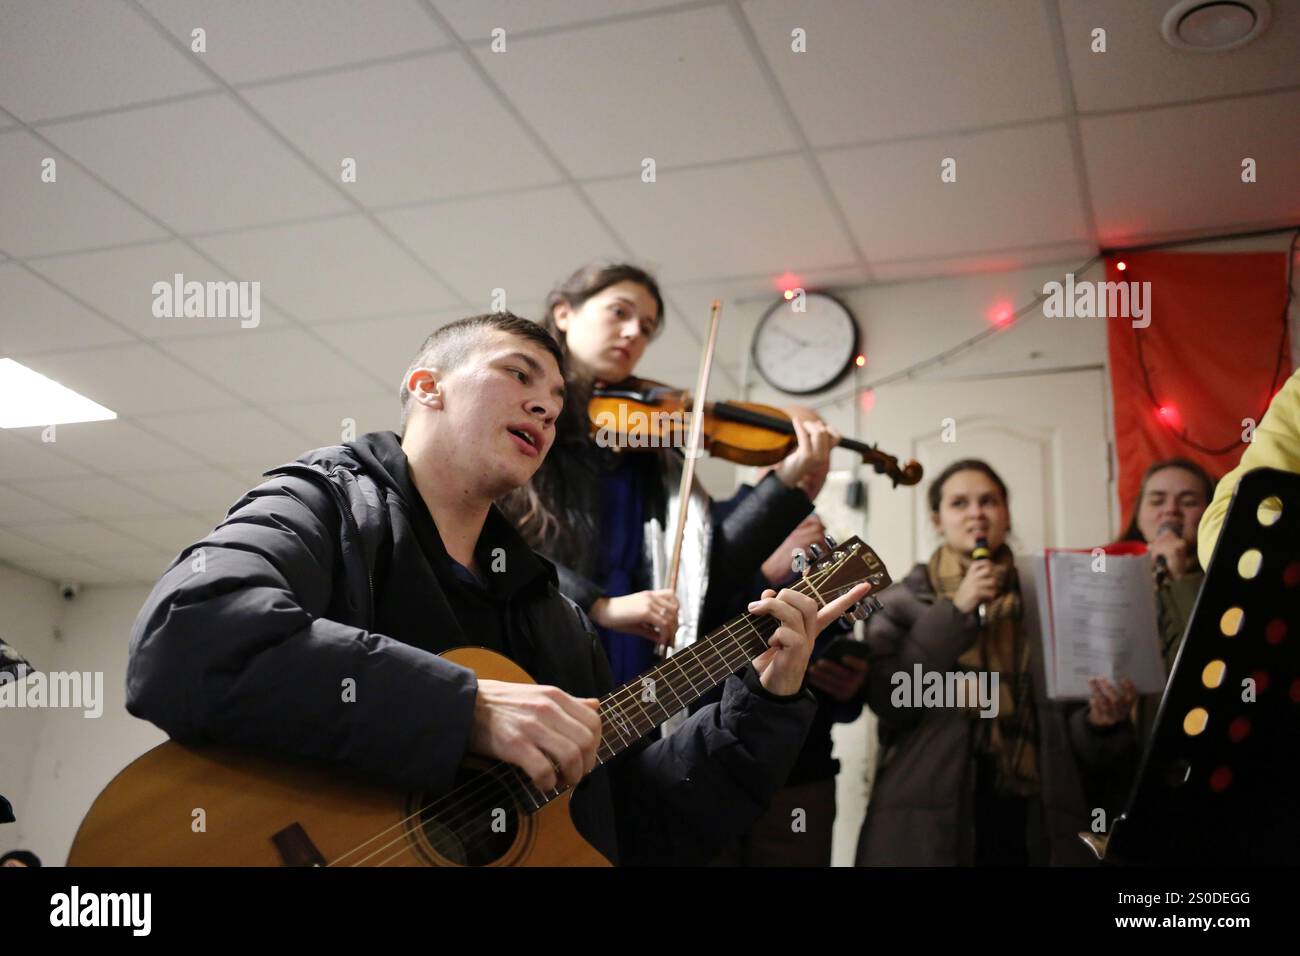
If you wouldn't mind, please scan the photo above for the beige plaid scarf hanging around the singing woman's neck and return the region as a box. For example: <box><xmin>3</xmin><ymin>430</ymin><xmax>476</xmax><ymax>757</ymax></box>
<box><xmin>928</xmin><ymin>544</ymin><xmax>1039</xmax><ymax>796</ymax></box>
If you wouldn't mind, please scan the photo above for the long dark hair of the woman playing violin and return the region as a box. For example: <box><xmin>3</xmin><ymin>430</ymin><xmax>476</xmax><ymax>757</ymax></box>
<box><xmin>498</xmin><ymin>263</ymin><xmax>664</xmax><ymax>564</ymax></box>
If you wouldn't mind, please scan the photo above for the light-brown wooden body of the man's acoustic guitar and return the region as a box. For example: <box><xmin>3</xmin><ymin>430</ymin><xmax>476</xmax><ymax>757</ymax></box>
<box><xmin>68</xmin><ymin>648</ymin><xmax>610</xmax><ymax>866</ymax></box>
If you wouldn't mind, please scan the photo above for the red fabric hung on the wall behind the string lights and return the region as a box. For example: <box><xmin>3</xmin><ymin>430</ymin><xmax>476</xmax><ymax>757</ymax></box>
<box><xmin>1106</xmin><ymin>252</ymin><xmax>1291</xmax><ymax>531</ymax></box>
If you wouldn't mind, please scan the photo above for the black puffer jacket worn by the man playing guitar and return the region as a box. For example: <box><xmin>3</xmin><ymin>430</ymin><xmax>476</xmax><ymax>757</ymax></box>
<box><xmin>126</xmin><ymin>432</ymin><xmax>815</xmax><ymax>862</ymax></box>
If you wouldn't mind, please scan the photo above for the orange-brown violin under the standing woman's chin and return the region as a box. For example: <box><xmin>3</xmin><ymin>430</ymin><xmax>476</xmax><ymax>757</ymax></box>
<box><xmin>588</xmin><ymin>378</ymin><xmax>922</xmax><ymax>488</ymax></box>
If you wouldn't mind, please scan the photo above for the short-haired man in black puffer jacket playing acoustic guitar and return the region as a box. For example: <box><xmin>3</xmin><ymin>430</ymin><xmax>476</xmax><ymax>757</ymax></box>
<box><xmin>127</xmin><ymin>313</ymin><xmax>866</xmax><ymax>864</ymax></box>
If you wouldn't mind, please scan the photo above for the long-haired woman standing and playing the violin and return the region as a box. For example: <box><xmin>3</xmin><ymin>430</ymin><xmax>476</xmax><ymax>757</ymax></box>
<box><xmin>502</xmin><ymin>264</ymin><xmax>840</xmax><ymax>683</ymax></box>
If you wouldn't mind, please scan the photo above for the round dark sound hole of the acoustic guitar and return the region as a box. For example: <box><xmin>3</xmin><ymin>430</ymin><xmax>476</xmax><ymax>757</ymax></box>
<box><xmin>420</xmin><ymin>767</ymin><xmax>520</xmax><ymax>866</ymax></box>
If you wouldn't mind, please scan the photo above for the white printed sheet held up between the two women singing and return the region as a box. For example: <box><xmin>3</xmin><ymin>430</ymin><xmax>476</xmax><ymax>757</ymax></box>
<box><xmin>1035</xmin><ymin>549</ymin><xmax>1166</xmax><ymax>700</ymax></box>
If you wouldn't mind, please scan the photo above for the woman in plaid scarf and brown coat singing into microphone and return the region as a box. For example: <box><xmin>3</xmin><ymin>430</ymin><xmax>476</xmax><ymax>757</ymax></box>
<box><xmin>858</xmin><ymin>459</ymin><xmax>1088</xmax><ymax>866</ymax></box>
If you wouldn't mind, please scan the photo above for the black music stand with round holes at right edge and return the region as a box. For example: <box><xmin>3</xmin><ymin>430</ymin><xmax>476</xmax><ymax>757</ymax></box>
<box><xmin>1104</xmin><ymin>468</ymin><xmax>1300</xmax><ymax>865</ymax></box>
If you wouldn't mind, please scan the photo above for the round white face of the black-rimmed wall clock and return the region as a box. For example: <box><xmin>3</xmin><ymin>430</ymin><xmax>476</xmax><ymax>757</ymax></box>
<box><xmin>753</xmin><ymin>293</ymin><xmax>858</xmax><ymax>395</ymax></box>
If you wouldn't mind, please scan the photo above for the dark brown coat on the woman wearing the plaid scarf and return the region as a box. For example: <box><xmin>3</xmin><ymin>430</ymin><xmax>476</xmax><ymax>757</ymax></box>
<box><xmin>857</xmin><ymin>564</ymin><xmax>1092</xmax><ymax>866</ymax></box>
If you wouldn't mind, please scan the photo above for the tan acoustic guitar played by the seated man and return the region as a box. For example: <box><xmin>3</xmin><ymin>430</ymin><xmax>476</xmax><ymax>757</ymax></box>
<box><xmin>68</xmin><ymin>538</ymin><xmax>892</xmax><ymax>866</ymax></box>
